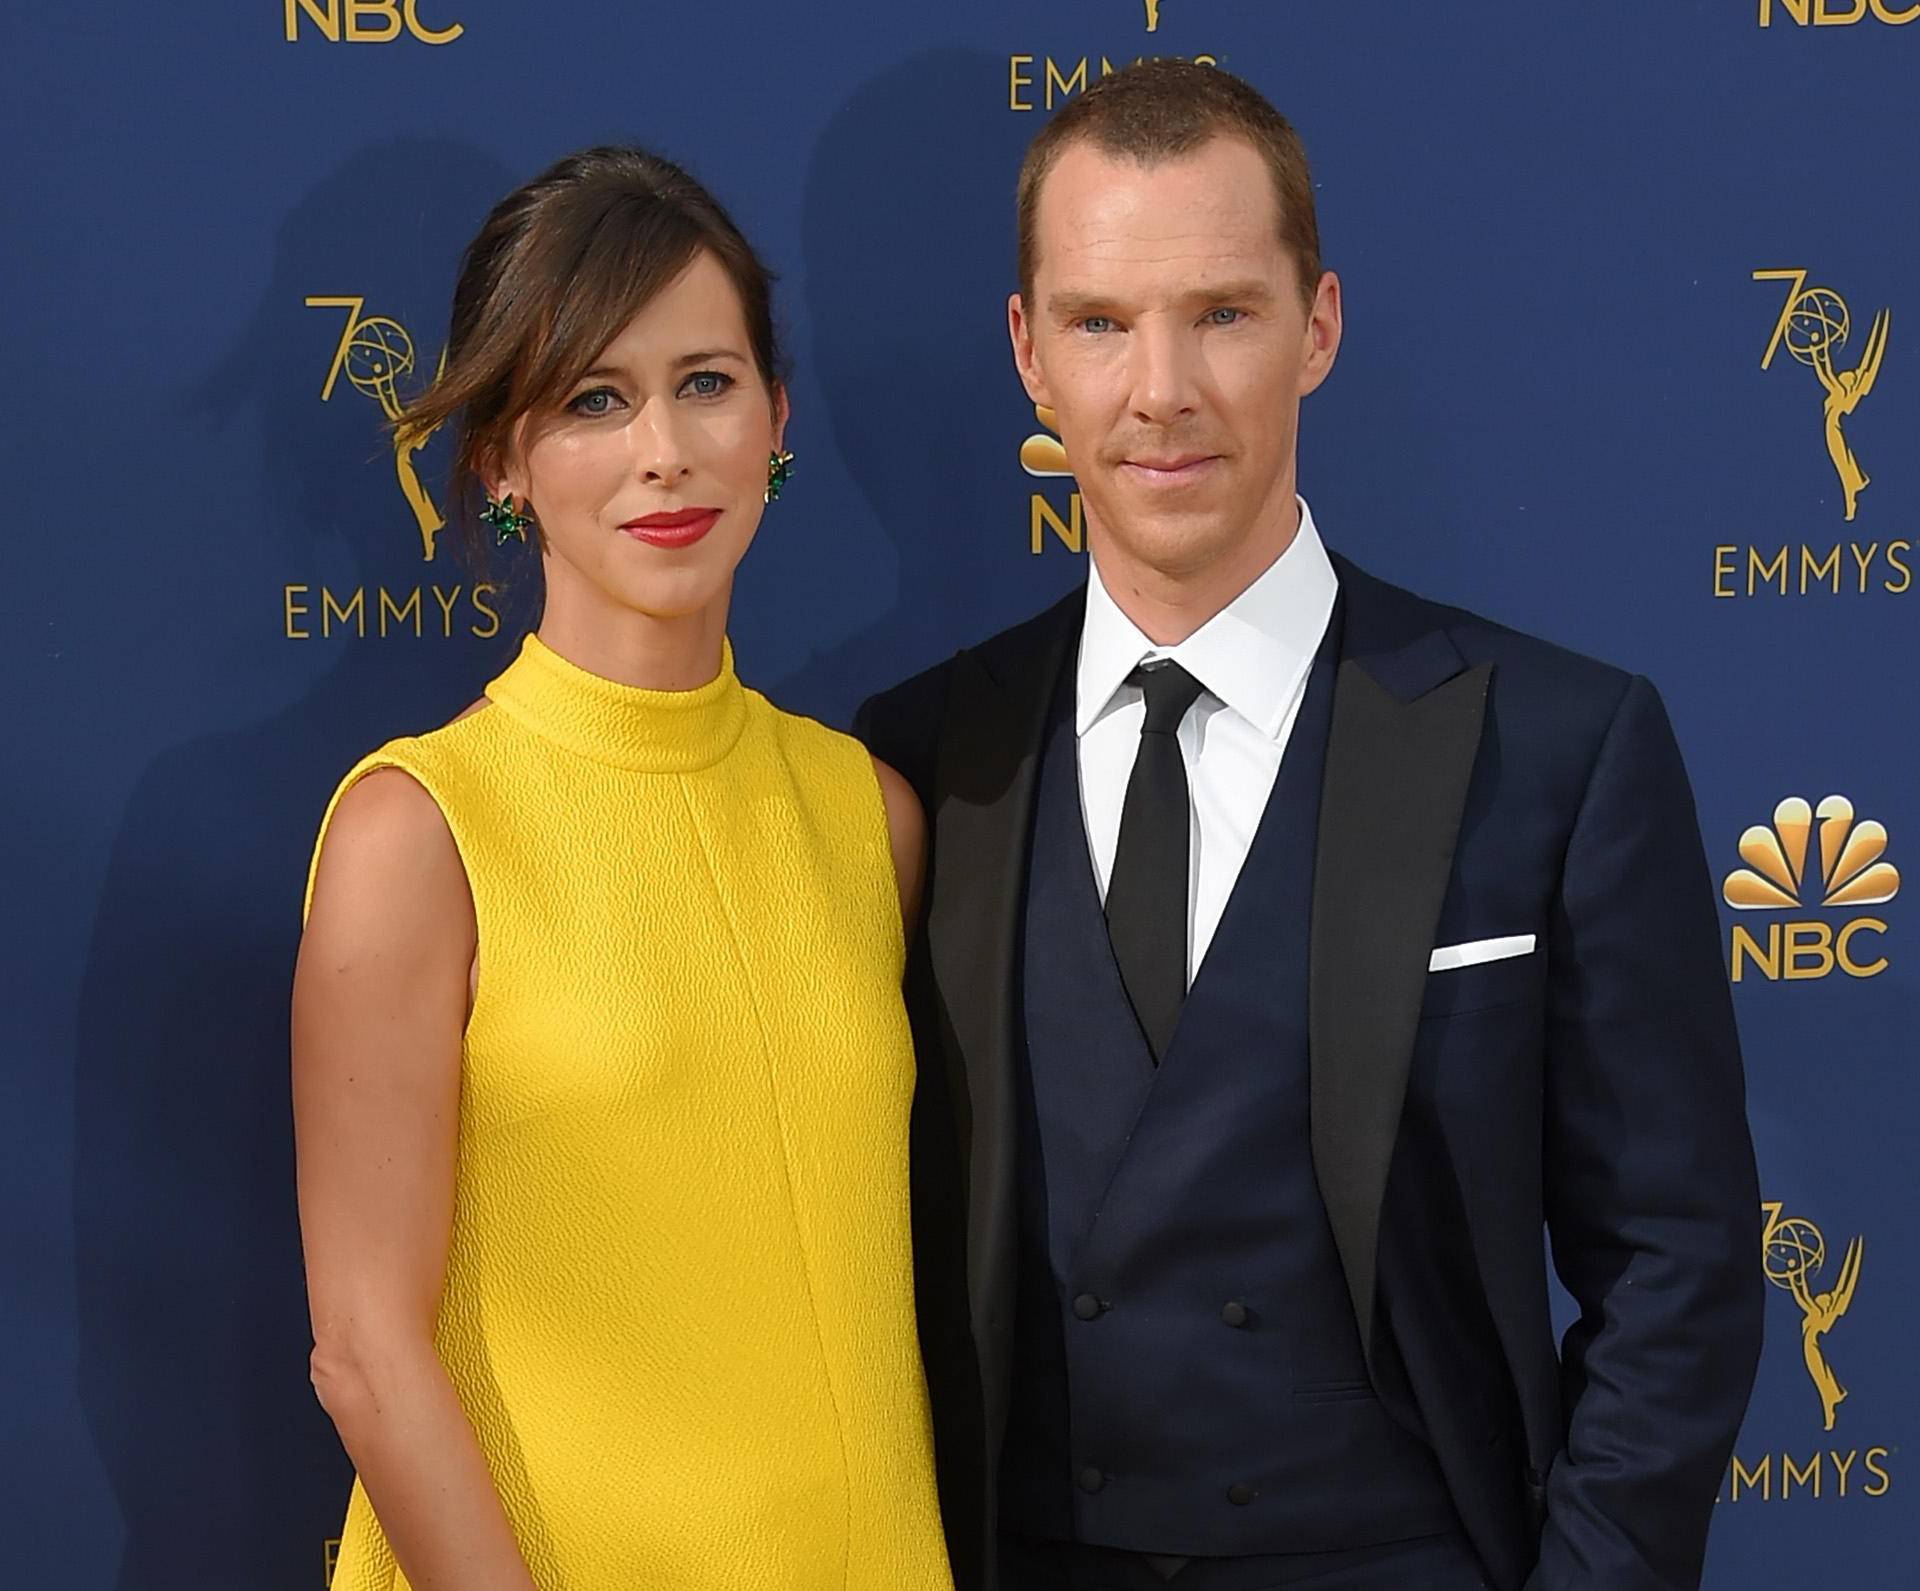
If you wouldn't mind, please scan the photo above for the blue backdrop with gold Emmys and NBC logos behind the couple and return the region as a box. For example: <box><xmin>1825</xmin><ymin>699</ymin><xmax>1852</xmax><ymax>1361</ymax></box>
<box><xmin>0</xmin><ymin>0</ymin><xmax>1920</xmax><ymax>1591</ymax></box>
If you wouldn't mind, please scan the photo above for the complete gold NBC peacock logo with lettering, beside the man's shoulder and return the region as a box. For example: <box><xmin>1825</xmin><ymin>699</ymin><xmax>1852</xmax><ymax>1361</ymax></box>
<box><xmin>1720</xmin><ymin>795</ymin><xmax>1901</xmax><ymax>983</ymax></box>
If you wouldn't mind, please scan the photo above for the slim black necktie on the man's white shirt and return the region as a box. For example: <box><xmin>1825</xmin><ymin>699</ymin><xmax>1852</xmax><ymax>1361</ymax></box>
<box><xmin>1106</xmin><ymin>660</ymin><xmax>1202</xmax><ymax>1065</ymax></box>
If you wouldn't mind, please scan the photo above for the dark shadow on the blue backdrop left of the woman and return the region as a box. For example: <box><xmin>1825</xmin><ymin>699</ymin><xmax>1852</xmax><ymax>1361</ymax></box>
<box><xmin>75</xmin><ymin>140</ymin><xmax>515</xmax><ymax>1591</ymax></box>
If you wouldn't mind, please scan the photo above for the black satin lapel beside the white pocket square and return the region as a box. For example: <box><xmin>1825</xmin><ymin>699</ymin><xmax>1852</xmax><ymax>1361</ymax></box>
<box><xmin>1308</xmin><ymin>658</ymin><xmax>1492</xmax><ymax>1359</ymax></box>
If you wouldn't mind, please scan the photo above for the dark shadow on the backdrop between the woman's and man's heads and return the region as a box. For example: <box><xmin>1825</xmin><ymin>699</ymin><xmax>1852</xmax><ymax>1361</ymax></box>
<box><xmin>774</xmin><ymin>50</ymin><xmax>1079</xmax><ymax>724</ymax></box>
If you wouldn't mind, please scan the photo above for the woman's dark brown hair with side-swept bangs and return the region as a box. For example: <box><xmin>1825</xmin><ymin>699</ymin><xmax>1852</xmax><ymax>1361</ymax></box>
<box><xmin>397</xmin><ymin>146</ymin><xmax>783</xmax><ymax>551</ymax></box>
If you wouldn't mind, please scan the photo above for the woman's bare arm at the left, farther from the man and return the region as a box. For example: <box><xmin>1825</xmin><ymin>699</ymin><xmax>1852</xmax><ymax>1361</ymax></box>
<box><xmin>294</xmin><ymin>770</ymin><xmax>534</xmax><ymax>1591</ymax></box>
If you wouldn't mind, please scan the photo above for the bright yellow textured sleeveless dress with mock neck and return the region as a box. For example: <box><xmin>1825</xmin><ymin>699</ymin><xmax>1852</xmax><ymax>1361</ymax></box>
<box><xmin>307</xmin><ymin>637</ymin><xmax>952</xmax><ymax>1591</ymax></box>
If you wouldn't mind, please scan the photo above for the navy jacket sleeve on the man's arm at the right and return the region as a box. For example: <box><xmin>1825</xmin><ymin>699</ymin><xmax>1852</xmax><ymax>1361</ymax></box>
<box><xmin>1526</xmin><ymin>677</ymin><xmax>1764</xmax><ymax>1591</ymax></box>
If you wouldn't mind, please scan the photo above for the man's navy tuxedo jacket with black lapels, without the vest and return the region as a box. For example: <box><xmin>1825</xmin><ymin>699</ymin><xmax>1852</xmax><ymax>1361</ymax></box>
<box><xmin>856</xmin><ymin>558</ymin><xmax>1764</xmax><ymax>1591</ymax></box>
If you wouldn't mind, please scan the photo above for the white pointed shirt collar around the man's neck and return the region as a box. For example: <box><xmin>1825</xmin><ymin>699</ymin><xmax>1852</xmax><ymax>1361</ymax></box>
<box><xmin>1073</xmin><ymin>499</ymin><xmax>1340</xmax><ymax>739</ymax></box>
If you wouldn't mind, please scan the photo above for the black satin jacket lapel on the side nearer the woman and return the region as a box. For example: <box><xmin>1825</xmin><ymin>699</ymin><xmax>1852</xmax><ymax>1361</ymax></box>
<box><xmin>927</xmin><ymin>616</ymin><xmax>1077</xmax><ymax>1418</ymax></box>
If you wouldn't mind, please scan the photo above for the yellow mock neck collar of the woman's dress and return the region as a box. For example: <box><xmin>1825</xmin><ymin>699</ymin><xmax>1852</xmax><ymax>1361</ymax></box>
<box><xmin>486</xmin><ymin>635</ymin><xmax>747</xmax><ymax>773</ymax></box>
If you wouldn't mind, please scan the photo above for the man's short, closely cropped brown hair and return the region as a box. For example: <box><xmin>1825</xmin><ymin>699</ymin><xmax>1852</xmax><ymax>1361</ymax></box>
<box><xmin>1016</xmin><ymin>59</ymin><xmax>1321</xmax><ymax>307</ymax></box>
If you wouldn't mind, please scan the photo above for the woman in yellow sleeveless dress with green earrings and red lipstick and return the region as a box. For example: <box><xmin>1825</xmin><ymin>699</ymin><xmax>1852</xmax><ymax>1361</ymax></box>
<box><xmin>294</xmin><ymin>150</ymin><xmax>950</xmax><ymax>1591</ymax></box>
